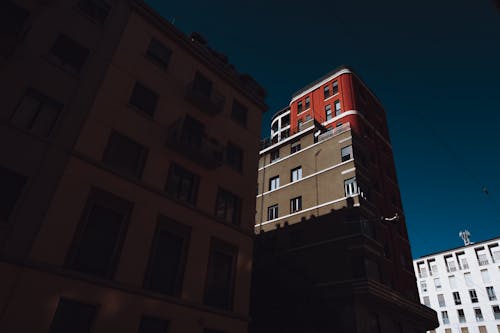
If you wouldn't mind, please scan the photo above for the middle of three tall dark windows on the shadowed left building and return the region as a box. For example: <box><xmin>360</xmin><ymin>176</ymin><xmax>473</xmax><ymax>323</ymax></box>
<box><xmin>144</xmin><ymin>216</ymin><xmax>191</xmax><ymax>296</ymax></box>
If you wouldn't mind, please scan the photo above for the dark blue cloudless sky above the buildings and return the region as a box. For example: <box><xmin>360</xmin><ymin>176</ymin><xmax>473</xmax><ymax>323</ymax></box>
<box><xmin>147</xmin><ymin>0</ymin><xmax>500</xmax><ymax>257</ymax></box>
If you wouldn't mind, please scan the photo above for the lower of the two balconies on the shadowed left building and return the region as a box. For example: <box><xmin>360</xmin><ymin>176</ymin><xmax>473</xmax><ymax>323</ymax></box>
<box><xmin>167</xmin><ymin>119</ymin><xmax>224</xmax><ymax>169</ymax></box>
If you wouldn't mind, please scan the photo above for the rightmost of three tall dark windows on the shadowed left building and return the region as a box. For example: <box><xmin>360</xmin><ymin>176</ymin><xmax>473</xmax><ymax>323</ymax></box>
<box><xmin>204</xmin><ymin>239</ymin><xmax>238</xmax><ymax>310</ymax></box>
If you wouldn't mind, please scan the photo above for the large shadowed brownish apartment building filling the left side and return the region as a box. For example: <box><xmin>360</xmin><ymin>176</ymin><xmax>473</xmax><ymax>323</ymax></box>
<box><xmin>0</xmin><ymin>0</ymin><xmax>266</xmax><ymax>333</ymax></box>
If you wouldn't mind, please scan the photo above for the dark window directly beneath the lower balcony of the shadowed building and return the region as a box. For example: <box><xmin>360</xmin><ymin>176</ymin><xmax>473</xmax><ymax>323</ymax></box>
<box><xmin>165</xmin><ymin>163</ymin><xmax>200</xmax><ymax>205</ymax></box>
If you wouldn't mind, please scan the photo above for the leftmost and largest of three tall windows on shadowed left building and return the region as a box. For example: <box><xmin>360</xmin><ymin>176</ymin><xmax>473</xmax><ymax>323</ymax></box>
<box><xmin>68</xmin><ymin>188</ymin><xmax>133</xmax><ymax>278</ymax></box>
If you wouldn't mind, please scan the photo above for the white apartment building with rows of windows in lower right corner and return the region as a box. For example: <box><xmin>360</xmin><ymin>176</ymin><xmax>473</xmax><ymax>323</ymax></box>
<box><xmin>413</xmin><ymin>238</ymin><xmax>500</xmax><ymax>333</ymax></box>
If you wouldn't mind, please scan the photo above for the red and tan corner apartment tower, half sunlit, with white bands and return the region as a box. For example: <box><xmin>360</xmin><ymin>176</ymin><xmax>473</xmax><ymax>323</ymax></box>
<box><xmin>251</xmin><ymin>67</ymin><xmax>437</xmax><ymax>332</ymax></box>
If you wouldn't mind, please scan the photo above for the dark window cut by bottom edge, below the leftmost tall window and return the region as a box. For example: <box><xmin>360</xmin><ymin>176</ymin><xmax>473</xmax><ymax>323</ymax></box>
<box><xmin>49</xmin><ymin>299</ymin><xmax>97</xmax><ymax>333</ymax></box>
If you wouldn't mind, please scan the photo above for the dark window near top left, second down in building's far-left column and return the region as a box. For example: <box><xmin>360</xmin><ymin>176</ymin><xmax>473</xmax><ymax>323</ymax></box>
<box><xmin>49</xmin><ymin>34</ymin><xmax>89</xmax><ymax>74</ymax></box>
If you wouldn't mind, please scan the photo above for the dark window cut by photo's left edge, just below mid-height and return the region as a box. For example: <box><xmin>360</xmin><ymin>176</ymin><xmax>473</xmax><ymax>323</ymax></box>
<box><xmin>0</xmin><ymin>167</ymin><xmax>26</xmax><ymax>223</ymax></box>
